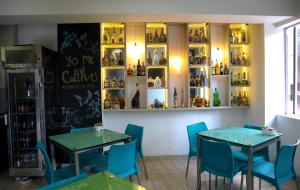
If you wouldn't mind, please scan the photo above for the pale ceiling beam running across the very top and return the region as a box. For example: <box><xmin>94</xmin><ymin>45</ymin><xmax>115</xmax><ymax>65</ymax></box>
<box><xmin>0</xmin><ymin>0</ymin><xmax>299</xmax><ymax>16</ymax></box>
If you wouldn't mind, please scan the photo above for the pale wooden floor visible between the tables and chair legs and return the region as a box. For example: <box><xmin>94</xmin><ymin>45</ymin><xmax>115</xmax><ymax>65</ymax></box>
<box><xmin>0</xmin><ymin>157</ymin><xmax>296</xmax><ymax>190</ymax></box>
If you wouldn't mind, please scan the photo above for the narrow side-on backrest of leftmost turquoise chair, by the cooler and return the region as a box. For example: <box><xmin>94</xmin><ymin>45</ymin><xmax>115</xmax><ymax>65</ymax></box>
<box><xmin>37</xmin><ymin>141</ymin><xmax>54</xmax><ymax>184</ymax></box>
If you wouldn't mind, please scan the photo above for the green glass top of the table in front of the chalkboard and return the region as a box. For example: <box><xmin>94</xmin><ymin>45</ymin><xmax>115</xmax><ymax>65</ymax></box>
<box><xmin>49</xmin><ymin>128</ymin><xmax>131</xmax><ymax>151</ymax></box>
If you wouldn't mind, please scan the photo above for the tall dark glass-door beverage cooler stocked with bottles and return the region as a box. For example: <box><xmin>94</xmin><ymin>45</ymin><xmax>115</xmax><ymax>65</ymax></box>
<box><xmin>1</xmin><ymin>45</ymin><xmax>55</xmax><ymax>176</ymax></box>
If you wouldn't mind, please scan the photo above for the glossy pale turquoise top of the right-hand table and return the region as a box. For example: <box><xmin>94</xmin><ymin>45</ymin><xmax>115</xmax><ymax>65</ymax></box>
<box><xmin>198</xmin><ymin>126</ymin><xmax>281</xmax><ymax>147</ymax></box>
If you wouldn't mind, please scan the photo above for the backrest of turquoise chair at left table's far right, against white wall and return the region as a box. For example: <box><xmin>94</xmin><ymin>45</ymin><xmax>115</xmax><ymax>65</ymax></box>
<box><xmin>125</xmin><ymin>124</ymin><xmax>144</xmax><ymax>154</ymax></box>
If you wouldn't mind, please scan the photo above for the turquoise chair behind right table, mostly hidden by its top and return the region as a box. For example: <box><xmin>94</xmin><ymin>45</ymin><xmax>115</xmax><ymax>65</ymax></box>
<box><xmin>233</xmin><ymin>124</ymin><xmax>270</xmax><ymax>163</ymax></box>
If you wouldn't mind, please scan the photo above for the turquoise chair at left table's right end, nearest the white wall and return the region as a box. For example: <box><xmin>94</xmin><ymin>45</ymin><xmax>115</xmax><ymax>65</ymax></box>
<box><xmin>125</xmin><ymin>124</ymin><xmax>148</xmax><ymax>179</ymax></box>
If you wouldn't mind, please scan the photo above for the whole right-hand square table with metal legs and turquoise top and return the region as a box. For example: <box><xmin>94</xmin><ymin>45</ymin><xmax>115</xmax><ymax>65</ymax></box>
<box><xmin>197</xmin><ymin>126</ymin><xmax>281</xmax><ymax>190</ymax></box>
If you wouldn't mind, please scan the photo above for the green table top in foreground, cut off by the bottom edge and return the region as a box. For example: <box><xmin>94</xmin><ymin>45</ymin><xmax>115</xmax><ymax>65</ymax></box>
<box><xmin>57</xmin><ymin>173</ymin><xmax>145</xmax><ymax>190</ymax></box>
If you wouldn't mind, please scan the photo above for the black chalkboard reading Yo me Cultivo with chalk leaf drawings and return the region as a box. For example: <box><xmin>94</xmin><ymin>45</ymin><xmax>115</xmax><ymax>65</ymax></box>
<box><xmin>57</xmin><ymin>23</ymin><xmax>102</xmax><ymax>127</ymax></box>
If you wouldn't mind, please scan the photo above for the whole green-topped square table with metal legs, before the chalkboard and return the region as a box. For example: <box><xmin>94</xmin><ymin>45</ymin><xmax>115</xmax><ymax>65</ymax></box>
<box><xmin>49</xmin><ymin>128</ymin><xmax>131</xmax><ymax>175</ymax></box>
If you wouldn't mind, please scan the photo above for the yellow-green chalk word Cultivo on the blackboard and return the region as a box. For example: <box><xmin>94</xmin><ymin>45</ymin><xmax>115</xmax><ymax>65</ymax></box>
<box><xmin>61</xmin><ymin>69</ymin><xmax>98</xmax><ymax>84</ymax></box>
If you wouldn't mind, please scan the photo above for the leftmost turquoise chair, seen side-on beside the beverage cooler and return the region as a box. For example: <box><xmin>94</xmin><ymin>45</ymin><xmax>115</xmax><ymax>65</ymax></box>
<box><xmin>37</xmin><ymin>141</ymin><xmax>84</xmax><ymax>184</ymax></box>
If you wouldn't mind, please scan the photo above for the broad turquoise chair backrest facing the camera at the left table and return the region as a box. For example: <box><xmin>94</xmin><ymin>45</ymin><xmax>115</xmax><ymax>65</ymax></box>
<box><xmin>107</xmin><ymin>140</ymin><xmax>137</xmax><ymax>177</ymax></box>
